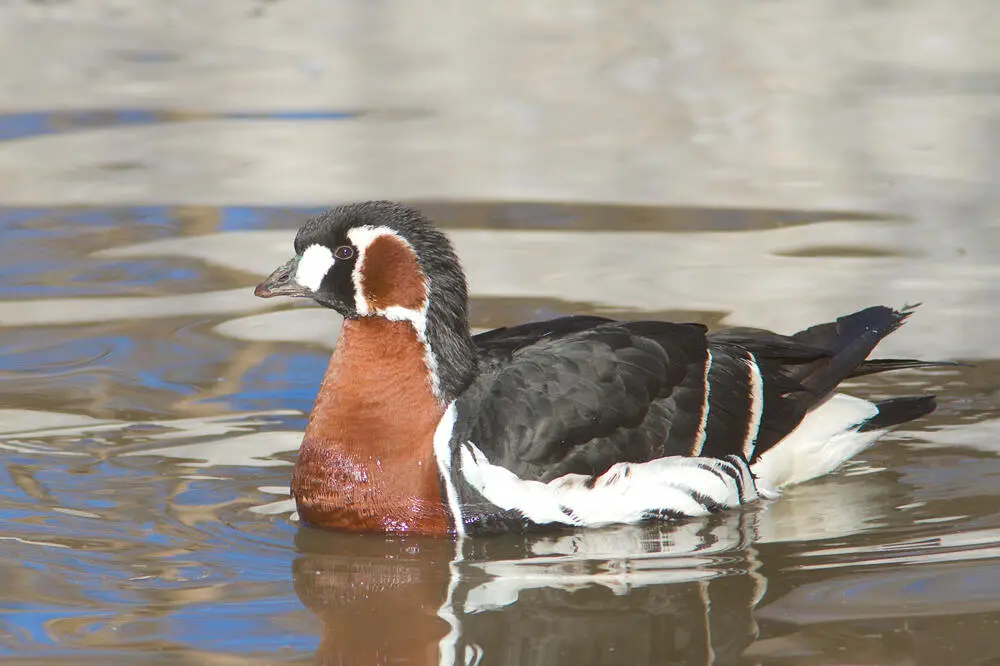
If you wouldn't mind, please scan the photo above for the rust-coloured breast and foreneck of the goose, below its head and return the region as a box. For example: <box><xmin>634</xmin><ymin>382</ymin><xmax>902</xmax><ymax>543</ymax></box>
<box><xmin>292</xmin><ymin>317</ymin><xmax>451</xmax><ymax>534</ymax></box>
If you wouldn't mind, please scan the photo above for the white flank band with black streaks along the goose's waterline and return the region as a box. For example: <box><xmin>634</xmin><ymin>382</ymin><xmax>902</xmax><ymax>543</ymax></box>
<box><xmin>461</xmin><ymin>442</ymin><xmax>757</xmax><ymax>527</ymax></box>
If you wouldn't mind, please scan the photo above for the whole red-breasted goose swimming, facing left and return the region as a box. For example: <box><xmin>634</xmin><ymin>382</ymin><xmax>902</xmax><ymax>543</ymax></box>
<box><xmin>254</xmin><ymin>202</ymin><xmax>935</xmax><ymax>534</ymax></box>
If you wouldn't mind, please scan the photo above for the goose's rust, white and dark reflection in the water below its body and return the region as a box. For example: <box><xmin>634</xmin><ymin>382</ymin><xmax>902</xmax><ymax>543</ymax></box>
<box><xmin>292</xmin><ymin>511</ymin><xmax>765</xmax><ymax>664</ymax></box>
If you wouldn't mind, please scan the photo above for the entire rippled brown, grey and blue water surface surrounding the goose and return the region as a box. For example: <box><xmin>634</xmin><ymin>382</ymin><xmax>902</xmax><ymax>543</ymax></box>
<box><xmin>0</xmin><ymin>0</ymin><xmax>1000</xmax><ymax>666</ymax></box>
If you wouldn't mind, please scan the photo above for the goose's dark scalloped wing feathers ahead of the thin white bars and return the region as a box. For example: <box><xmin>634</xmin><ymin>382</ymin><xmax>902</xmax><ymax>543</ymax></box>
<box><xmin>455</xmin><ymin>319</ymin><xmax>707</xmax><ymax>481</ymax></box>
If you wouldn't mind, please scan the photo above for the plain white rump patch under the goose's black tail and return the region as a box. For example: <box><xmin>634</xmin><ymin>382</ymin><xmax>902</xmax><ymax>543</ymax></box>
<box><xmin>753</xmin><ymin>393</ymin><xmax>885</xmax><ymax>496</ymax></box>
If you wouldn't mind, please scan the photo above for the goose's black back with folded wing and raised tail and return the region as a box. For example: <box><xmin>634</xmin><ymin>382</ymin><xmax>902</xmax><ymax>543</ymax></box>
<box><xmin>453</xmin><ymin>307</ymin><xmax>936</xmax><ymax>481</ymax></box>
